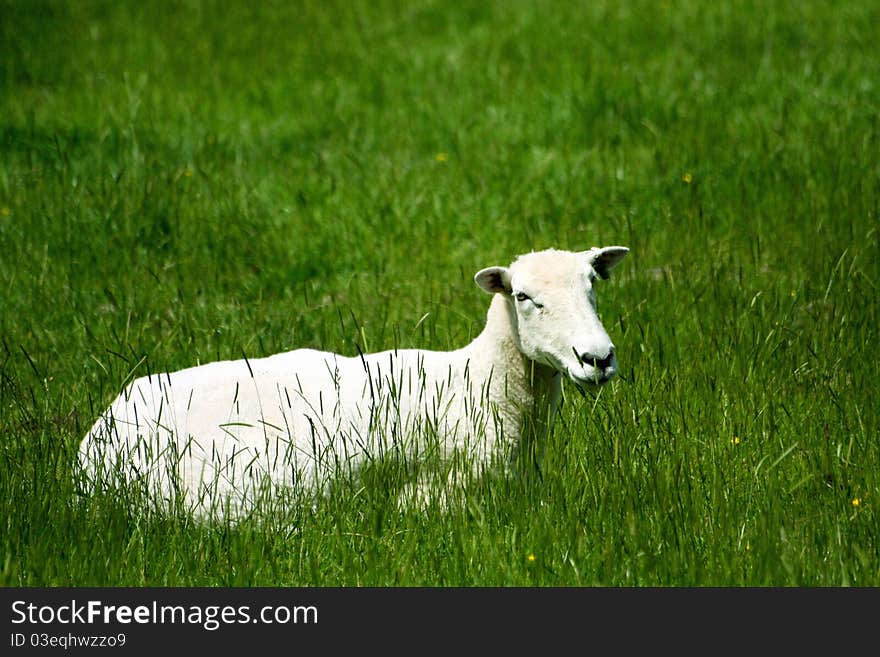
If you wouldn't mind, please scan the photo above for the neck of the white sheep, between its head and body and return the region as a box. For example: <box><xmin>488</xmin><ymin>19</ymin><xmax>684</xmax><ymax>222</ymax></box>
<box><xmin>469</xmin><ymin>294</ymin><xmax>562</xmax><ymax>442</ymax></box>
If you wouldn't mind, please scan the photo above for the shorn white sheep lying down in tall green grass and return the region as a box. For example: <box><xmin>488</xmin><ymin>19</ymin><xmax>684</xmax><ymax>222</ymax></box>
<box><xmin>79</xmin><ymin>246</ymin><xmax>629</xmax><ymax>518</ymax></box>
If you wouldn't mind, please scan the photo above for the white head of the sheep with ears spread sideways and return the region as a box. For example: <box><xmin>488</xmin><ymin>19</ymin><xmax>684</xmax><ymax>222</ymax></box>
<box><xmin>474</xmin><ymin>246</ymin><xmax>629</xmax><ymax>386</ymax></box>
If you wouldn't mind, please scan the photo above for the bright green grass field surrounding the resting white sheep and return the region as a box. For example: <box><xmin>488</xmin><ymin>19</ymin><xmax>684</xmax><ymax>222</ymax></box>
<box><xmin>0</xmin><ymin>0</ymin><xmax>880</xmax><ymax>586</ymax></box>
